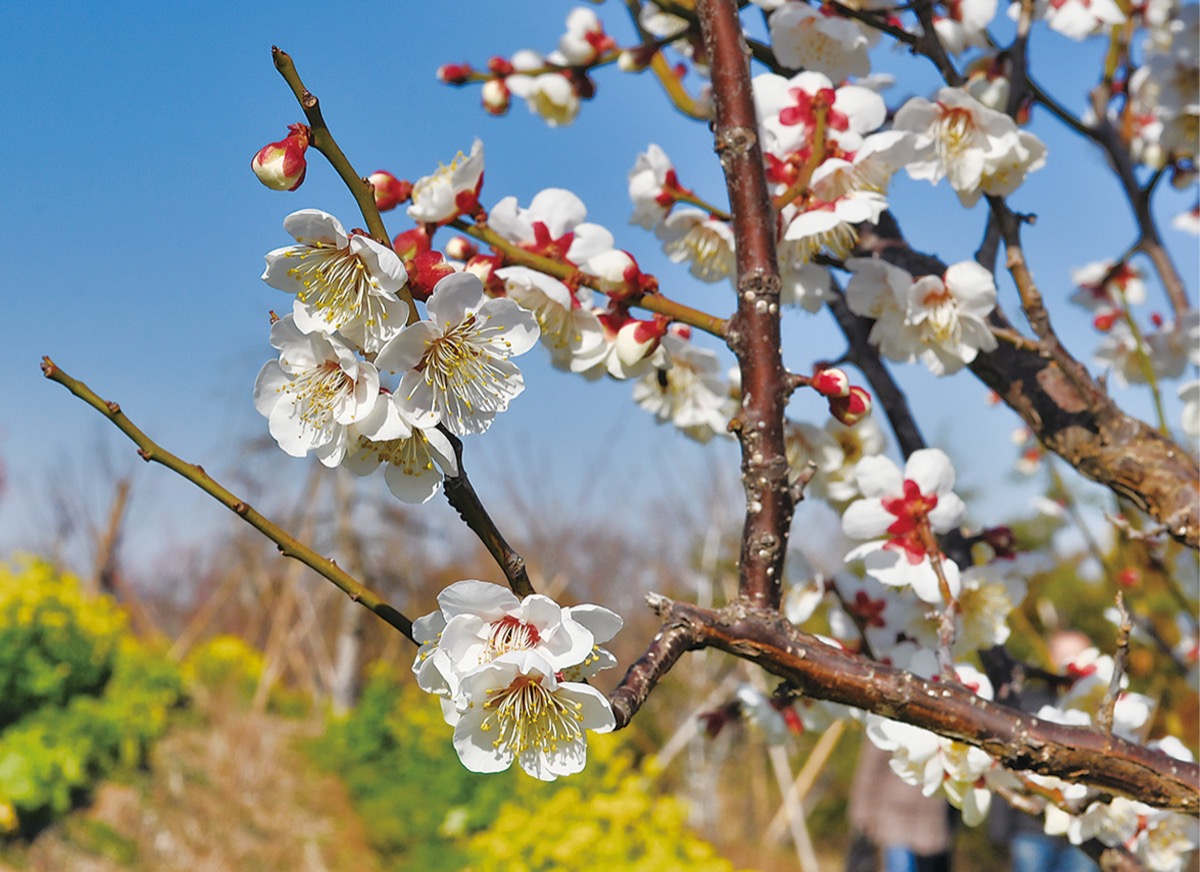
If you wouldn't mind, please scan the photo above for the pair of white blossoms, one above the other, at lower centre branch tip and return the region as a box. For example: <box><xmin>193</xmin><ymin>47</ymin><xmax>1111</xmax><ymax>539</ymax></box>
<box><xmin>413</xmin><ymin>581</ymin><xmax>622</xmax><ymax>781</ymax></box>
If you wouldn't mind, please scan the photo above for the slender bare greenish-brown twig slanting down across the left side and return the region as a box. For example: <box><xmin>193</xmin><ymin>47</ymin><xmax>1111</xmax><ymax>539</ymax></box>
<box><xmin>42</xmin><ymin>357</ymin><xmax>413</xmax><ymax>639</ymax></box>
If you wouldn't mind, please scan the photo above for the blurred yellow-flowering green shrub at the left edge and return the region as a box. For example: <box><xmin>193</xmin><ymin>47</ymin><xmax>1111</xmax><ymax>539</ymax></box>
<box><xmin>0</xmin><ymin>561</ymin><xmax>184</xmax><ymax>835</ymax></box>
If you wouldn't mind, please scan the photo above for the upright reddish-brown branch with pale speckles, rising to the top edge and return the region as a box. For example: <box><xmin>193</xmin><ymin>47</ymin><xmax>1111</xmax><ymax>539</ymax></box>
<box><xmin>696</xmin><ymin>0</ymin><xmax>792</xmax><ymax>608</ymax></box>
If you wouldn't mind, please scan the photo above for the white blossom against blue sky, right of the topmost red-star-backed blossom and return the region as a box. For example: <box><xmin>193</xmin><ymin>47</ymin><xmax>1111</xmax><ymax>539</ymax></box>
<box><xmin>894</xmin><ymin>88</ymin><xmax>1045</xmax><ymax>206</ymax></box>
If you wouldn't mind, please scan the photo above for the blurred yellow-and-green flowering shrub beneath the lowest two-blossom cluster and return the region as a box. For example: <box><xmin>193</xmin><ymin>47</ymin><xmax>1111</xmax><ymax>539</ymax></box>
<box><xmin>314</xmin><ymin>672</ymin><xmax>732</xmax><ymax>872</ymax></box>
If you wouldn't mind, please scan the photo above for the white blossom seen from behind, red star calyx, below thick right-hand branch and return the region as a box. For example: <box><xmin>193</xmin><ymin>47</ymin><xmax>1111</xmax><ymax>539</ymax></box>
<box><xmin>842</xmin><ymin>449</ymin><xmax>966</xmax><ymax>603</ymax></box>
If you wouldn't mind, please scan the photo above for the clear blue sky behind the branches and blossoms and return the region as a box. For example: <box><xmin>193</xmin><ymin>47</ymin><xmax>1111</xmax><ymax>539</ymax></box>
<box><xmin>0</xmin><ymin>0</ymin><xmax>1198</xmax><ymax>573</ymax></box>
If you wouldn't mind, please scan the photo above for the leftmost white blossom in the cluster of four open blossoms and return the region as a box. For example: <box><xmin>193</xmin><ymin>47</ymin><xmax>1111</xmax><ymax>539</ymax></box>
<box><xmin>254</xmin><ymin>315</ymin><xmax>393</xmax><ymax>467</ymax></box>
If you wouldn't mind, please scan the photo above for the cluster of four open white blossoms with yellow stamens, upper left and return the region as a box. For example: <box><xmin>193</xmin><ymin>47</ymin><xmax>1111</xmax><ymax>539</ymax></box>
<box><xmin>254</xmin><ymin>199</ymin><xmax>538</xmax><ymax>503</ymax></box>
